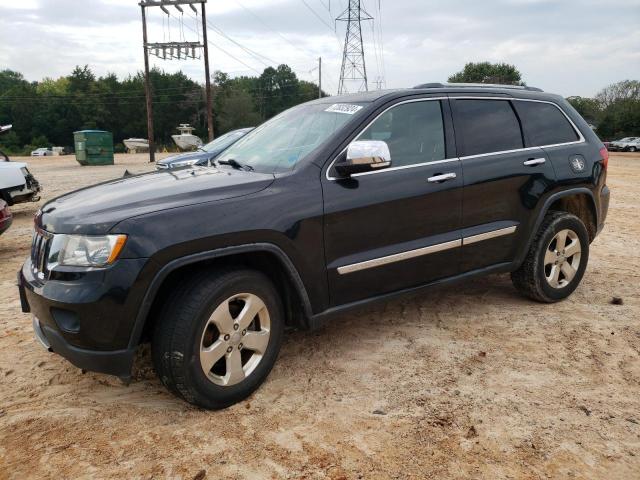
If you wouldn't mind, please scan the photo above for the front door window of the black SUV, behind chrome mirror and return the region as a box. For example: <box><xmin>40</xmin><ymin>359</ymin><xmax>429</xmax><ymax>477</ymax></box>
<box><xmin>358</xmin><ymin>101</ymin><xmax>445</xmax><ymax>167</ymax></box>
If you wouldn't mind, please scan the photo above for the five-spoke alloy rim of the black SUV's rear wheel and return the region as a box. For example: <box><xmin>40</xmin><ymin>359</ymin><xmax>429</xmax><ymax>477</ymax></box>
<box><xmin>544</xmin><ymin>229</ymin><xmax>582</xmax><ymax>288</ymax></box>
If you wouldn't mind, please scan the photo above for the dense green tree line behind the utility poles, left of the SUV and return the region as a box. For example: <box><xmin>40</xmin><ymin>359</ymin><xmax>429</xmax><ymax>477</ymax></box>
<box><xmin>0</xmin><ymin>65</ymin><xmax>326</xmax><ymax>155</ymax></box>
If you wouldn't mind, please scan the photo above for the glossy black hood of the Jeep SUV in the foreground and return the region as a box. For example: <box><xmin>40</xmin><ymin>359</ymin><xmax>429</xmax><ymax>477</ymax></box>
<box><xmin>37</xmin><ymin>167</ymin><xmax>274</xmax><ymax>235</ymax></box>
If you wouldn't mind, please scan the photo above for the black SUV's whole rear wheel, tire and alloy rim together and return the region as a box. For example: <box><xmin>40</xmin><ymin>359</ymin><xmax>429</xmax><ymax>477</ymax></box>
<box><xmin>511</xmin><ymin>212</ymin><xmax>589</xmax><ymax>303</ymax></box>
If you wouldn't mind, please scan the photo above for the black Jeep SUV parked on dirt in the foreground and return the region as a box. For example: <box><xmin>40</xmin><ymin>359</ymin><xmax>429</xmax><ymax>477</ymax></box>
<box><xmin>18</xmin><ymin>84</ymin><xmax>609</xmax><ymax>408</ymax></box>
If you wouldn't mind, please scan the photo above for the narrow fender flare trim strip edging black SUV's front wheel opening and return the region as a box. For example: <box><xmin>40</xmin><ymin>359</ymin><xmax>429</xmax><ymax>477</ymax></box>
<box><xmin>129</xmin><ymin>243</ymin><xmax>313</xmax><ymax>349</ymax></box>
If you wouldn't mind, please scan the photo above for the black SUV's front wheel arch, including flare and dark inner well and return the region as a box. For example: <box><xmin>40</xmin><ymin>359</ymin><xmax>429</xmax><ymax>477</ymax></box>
<box><xmin>129</xmin><ymin>243</ymin><xmax>312</xmax><ymax>348</ymax></box>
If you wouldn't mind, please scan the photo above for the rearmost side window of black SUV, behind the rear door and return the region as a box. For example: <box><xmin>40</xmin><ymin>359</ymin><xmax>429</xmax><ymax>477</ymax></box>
<box><xmin>513</xmin><ymin>101</ymin><xmax>579</xmax><ymax>147</ymax></box>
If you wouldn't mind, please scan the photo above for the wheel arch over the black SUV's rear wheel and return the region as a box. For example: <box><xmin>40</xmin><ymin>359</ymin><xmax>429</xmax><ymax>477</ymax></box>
<box><xmin>514</xmin><ymin>187</ymin><xmax>598</xmax><ymax>269</ymax></box>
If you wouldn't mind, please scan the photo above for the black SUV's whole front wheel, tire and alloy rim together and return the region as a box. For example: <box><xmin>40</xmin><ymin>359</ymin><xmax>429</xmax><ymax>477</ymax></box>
<box><xmin>152</xmin><ymin>270</ymin><xmax>284</xmax><ymax>409</ymax></box>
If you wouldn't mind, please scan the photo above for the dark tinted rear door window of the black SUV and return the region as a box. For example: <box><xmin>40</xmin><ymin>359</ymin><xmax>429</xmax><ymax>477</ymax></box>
<box><xmin>455</xmin><ymin>100</ymin><xmax>523</xmax><ymax>155</ymax></box>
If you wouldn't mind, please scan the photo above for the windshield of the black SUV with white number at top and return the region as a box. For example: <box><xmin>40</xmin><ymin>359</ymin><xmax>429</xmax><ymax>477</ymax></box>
<box><xmin>218</xmin><ymin>104</ymin><xmax>363</xmax><ymax>173</ymax></box>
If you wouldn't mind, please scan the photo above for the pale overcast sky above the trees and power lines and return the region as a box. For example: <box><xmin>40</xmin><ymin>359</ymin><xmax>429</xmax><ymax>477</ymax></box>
<box><xmin>0</xmin><ymin>0</ymin><xmax>640</xmax><ymax>96</ymax></box>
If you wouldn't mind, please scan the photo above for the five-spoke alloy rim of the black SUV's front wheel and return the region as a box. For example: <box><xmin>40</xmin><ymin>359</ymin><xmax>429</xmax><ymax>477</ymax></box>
<box><xmin>200</xmin><ymin>293</ymin><xmax>271</xmax><ymax>387</ymax></box>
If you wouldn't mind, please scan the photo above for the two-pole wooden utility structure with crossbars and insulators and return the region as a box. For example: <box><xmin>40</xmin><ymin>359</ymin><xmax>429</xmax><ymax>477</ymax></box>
<box><xmin>139</xmin><ymin>0</ymin><xmax>213</xmax><ymax>162</ymax></box>
